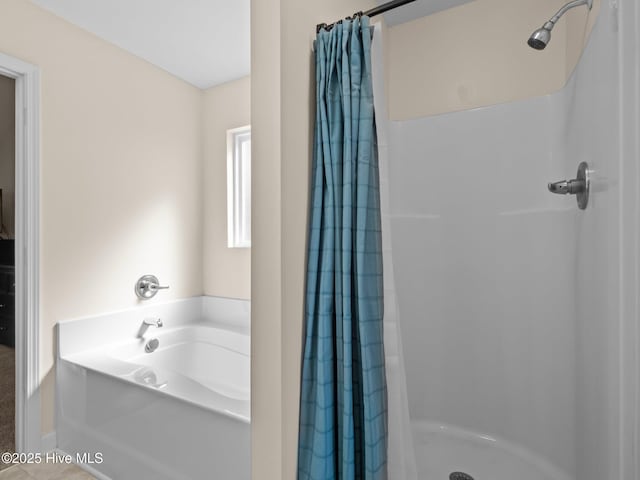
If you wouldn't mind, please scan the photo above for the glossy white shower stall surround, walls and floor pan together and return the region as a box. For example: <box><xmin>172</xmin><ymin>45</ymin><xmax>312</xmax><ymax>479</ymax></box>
<box><xmin>374</xmin><ymin>2</ymin><xmax>631</xmax><ymax>480</ymax></box>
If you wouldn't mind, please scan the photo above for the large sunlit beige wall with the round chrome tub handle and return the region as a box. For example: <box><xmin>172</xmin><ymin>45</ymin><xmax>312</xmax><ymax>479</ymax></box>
<box><xmin>0</xmin><ymin>0</ymin><xmax>203</xmax><ymax>432</ymax></box>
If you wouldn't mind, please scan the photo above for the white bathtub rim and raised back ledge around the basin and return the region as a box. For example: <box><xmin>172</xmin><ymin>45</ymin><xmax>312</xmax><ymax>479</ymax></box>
<box><xmin>56</xmin><ymin>296</ymin><xmax>251</xmax><ymax>424</ymax></box>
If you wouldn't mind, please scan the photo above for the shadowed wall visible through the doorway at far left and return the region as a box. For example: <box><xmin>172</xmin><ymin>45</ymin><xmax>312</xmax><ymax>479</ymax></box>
<box><xmin>0</xmin><ymin>75</ymin><xmax>16</xmax><ymax>238</ymax></box>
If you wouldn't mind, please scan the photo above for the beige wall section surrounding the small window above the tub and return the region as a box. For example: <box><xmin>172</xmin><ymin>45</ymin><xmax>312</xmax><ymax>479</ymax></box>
<box><xmin>203</xmin><ymin>77</ymin><xmax>251</xmax><ymax>299</ymax></box>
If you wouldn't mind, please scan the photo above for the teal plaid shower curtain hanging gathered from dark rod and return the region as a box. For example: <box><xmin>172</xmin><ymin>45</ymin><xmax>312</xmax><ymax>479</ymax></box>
<box><xmin>298</xmin><ymin>17</ymin><xmax>387</xmax><ymax>480</ymax></box>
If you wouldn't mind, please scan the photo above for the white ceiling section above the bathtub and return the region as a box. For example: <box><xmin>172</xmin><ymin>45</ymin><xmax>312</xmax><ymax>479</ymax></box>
<box><xmin>31</xmin><ymin>0</ymin><xmax>251</xmax><ymax>89</ymax></box>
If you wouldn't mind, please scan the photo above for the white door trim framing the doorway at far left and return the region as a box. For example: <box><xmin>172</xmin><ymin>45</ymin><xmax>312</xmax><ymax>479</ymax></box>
<box><xmin>0</xmin><ymin>53</ymin><xmax>41</xmax><ymax>452</ymax></box>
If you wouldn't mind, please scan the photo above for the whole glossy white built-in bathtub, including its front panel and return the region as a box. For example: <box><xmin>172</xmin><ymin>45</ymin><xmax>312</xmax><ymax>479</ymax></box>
<box><xmin>57</xmin><ymin>297</ymin><xmax>250</xmax><ymax>480</ymax></box>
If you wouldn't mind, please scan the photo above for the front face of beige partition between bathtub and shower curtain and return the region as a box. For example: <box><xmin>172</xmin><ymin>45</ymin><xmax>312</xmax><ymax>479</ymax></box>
<box><xmin>251</xmin><ymin>0</ymin><xmax>282</xmax><ymax>480</ymax></box>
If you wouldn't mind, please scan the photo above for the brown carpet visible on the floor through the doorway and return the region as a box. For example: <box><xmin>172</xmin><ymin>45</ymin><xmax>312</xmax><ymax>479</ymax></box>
<box><xmin>0</xmin><ymin>345</ymin><xmax>16</xmax><ymax>470</ymax></box>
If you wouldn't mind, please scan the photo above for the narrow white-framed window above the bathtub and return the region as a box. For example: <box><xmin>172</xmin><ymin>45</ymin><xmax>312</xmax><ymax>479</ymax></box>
<box><xmin>227</xmin><ymin>125</ymin><xmax>251</xmax><ymax>248</ymax></box>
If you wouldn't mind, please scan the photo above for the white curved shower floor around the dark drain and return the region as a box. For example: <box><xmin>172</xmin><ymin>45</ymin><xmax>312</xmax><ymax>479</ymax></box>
<box><xmin>412</xmin><ymin>422</ymin><xmax>570</xmax><ymax>480</ymax></box>
